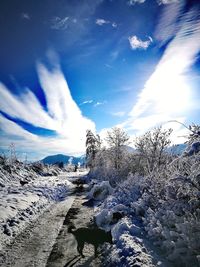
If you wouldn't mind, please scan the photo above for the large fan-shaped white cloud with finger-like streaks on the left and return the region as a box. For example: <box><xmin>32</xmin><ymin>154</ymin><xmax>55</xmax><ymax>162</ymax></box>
<box><xmin>0</xmin><ymin>60</ymin><xmax>95</xmax><ymax>159</ymax></box>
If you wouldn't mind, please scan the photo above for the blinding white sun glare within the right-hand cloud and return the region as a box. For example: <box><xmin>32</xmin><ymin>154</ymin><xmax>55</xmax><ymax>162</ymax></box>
<box><xmin>146</xmin><ymin>60</ymin><xmax>190</xmax><ymax>115</ymax></box>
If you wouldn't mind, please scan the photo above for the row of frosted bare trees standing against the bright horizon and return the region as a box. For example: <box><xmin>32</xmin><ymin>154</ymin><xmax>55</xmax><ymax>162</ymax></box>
<box><xmin>86</xmin><ymin>127</ymin><xmax>178</xmax><ymax>185</ymax></box>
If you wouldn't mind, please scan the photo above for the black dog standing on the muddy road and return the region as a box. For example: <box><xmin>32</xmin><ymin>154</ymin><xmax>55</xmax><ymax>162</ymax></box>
<box><xmin>68</xmin><ymin>226</ymin><xmax>112</xmax><ymax>257</ymax></box>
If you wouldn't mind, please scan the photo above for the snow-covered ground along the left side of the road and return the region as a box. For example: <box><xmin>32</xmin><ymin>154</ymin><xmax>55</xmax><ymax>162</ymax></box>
<box><xmin>0</xmin><ymin>176</ymin><xmax>70</xmax><ymax>248</ymax></box>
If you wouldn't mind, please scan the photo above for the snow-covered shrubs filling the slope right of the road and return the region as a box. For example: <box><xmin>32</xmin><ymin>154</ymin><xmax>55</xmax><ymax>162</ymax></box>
<box><xmin>91</xmin><ymin>142</ymin><xmax>200</xmax><ymax>266</ymax></box>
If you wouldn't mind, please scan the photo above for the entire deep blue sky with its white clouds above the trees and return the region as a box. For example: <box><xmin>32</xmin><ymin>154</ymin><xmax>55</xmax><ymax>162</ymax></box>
<box><xmin>0</xmin><ymin>0</ymin><xmax>200</xmax><ymax>160</ymax></box>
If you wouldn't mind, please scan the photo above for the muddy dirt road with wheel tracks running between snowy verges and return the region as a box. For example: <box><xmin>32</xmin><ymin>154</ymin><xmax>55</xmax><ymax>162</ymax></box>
<box><xmin>0</xmin><ymin>176</ymin><xmax>109</xmax><ymax>267</ymax></box>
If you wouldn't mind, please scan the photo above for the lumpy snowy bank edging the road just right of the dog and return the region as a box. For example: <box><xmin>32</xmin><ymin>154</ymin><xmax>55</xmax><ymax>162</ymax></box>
<box><xmin>96</xmin><ymin>195</ymin><xmax>167</xmax><ymax>267</ymax></box>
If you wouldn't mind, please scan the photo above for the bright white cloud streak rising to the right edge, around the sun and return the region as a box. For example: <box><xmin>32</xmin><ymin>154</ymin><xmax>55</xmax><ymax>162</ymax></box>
<box><xmin>121</xmin><ymin>5</ymin><xmax>200</xmax><ymax>140</ymax></box>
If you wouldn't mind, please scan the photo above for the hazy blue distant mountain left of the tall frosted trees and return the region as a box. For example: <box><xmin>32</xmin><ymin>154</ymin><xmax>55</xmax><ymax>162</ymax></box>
<box><xmin>40</xmin><ymin>154</ymin><xmax>85</xmax><ymax>165</ymax></box>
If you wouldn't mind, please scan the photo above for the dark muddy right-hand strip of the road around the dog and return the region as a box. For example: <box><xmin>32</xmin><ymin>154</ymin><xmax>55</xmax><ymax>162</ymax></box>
<box><xmin>46</xmin><ymin>195</ymin><xmax>101</xmax><ymax>267</ymax></box>
